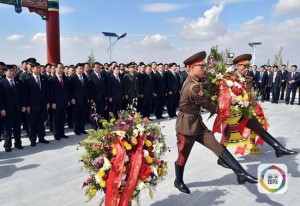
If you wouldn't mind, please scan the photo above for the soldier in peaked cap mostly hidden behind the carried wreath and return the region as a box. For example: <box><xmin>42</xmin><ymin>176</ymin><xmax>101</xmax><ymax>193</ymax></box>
<box><xmin>218</xmin><ymin>54</ymin><xmax>297</xmax><ymax>168</ymax></box>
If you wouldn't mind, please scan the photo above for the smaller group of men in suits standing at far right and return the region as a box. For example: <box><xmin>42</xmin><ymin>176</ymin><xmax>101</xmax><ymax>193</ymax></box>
<box><xmin>247</xmin><ymin>64</ymin><xmax>300</xmax><ymax>105</ymax></box>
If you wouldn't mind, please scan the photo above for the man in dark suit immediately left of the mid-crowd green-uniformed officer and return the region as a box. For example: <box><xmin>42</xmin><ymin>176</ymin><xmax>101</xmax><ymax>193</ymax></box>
<box><xmin>107</xmin><ymin>66</ymin><xmax>123</xmax><ymax>118</ymax></box>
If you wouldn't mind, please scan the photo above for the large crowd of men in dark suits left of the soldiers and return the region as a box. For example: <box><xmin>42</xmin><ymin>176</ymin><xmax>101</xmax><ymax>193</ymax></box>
<box><xmin>0</xmin><ymin>58</ymin><xmax>187</xmax><ymax>152</ymax></box>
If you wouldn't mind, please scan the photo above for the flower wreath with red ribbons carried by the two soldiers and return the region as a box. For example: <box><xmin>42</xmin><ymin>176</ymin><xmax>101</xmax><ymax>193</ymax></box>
<box><xmin>202</xmin><ymin>62</ymin><xmax>268</xmax><ymax>154</ymax></box>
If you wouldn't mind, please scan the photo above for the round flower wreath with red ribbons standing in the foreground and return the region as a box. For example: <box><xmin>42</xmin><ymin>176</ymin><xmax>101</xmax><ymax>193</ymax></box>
<box><xmin>80</xmin><ymin>104</ymin><xmax>168</xmax><ymax>206</ymax></box>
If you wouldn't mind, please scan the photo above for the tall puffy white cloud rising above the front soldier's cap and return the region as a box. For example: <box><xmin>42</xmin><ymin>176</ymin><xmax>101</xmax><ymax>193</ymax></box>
<box><xmin>179</xmin><ymin>3</ymin><xmax>227</xmax><ymax>40</ymax></box>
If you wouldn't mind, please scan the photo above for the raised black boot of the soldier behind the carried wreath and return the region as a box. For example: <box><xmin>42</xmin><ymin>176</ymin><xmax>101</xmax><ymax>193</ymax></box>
<box><xmin>246</xmin><ymin>119</ymin><xmax>297</xmax><ymax>157</ymax></box>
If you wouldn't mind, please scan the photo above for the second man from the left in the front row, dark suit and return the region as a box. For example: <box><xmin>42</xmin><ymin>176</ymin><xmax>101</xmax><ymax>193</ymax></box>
<box><xmin>24</xmin><ymin>63</ymin><xmax>49</xmax><ymax>147</ymax></box>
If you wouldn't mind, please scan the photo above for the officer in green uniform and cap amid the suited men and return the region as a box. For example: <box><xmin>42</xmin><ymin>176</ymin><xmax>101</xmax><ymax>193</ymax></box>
<box><xmin>123</xmin><ymin>62</ymin><xmax>139</xmax><ymax>106</ymax></box>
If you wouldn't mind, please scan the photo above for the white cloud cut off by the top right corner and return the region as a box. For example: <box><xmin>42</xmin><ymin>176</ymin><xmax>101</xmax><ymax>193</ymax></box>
<box><xmin>273</xmin><ymin>0</ymin><xmax>300</xmax><ymax>15</ymax></box>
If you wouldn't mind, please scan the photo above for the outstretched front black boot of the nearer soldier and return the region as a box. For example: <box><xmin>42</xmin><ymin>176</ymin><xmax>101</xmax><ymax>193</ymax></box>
<box><xmin>219</xmin><ymin>149</ymin><xmax>257</xmax><ymax>184</ymax></box>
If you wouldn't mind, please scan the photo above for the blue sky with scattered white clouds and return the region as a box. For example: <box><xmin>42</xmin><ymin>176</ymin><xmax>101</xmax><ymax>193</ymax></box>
<box><xmin>0</xmin><ymin>0</ymin><xmax>300</xmax><ymax>66</ymax></box>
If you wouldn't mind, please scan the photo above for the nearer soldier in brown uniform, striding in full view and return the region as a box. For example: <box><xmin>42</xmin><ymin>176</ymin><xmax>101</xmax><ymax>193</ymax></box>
<box><xmin>174</xmin><ymin>51</ymin><xmax>257</xmax><ymax>194</ymax></box>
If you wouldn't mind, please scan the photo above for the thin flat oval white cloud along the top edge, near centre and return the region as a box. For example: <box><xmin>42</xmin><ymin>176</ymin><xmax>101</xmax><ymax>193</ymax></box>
<box><xmin>141</xmin><ymin>3</ymin><xmax>185</xmax><ymax>13</ymax></box>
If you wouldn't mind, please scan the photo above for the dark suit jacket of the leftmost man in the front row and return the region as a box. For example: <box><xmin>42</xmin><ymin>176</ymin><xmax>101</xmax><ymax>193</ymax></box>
<box><xmin>0</xmin><ymin>78</ymin><xmax>26</xmax><ymax>114</ymax></box>
